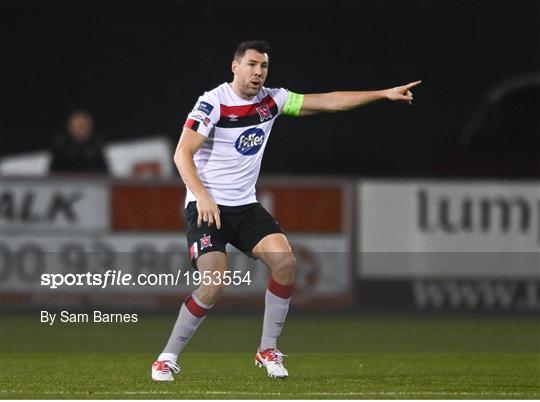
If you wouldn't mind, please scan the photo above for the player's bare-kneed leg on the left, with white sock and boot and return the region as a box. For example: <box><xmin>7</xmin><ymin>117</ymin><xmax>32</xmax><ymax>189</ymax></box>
<box><xmin>152</xmin><ymin>251</ymin><xmax>227</xmax><ymax>381</ymax></box>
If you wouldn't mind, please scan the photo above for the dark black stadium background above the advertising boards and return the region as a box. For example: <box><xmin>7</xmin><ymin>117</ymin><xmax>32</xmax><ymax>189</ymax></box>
<box><xmin>4</xmin><ymin>0</ymin><xmax>540</xmax><ymax>177</ymax></box>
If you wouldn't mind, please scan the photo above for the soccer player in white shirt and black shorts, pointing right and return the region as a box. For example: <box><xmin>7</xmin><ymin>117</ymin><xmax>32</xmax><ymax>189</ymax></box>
<box><xmin>152</xmin><ymin>41</ymin><xmax>421</xmax><ymax>381</ymax></box>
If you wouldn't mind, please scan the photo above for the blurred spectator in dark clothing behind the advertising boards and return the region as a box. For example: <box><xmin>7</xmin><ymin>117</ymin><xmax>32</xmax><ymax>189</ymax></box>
<box><xmin>50</xmin><ymin>110</ymin><xmax>107</xmax><ymax>173</ymax></box>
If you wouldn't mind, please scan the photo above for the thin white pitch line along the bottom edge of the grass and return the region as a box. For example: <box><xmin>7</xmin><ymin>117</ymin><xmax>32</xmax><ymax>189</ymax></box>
<box><xmin>0</xmin><ymin>390</ymin><xmax>540</xmax><ymax>397</ymax></box>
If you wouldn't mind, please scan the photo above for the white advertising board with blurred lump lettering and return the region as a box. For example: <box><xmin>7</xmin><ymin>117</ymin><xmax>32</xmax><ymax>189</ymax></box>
<box><xmin>357</xmin><ymin>181</ymin><xmax>540</xmax><ymax>277</ymax></box>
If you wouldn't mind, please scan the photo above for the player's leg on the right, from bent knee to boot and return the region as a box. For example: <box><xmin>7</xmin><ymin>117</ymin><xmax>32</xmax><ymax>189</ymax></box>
<box><xmin>253</xmin><ymin>233</ymin><xmax>295</xmax><ymax>378</ymax></box>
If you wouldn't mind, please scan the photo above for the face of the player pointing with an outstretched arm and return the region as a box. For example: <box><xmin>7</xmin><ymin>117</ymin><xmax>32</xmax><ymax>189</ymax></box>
<box><xmin>232</xmin><ymin>49</ymin><xmax>268</xmax><ymax>98</ymax></box>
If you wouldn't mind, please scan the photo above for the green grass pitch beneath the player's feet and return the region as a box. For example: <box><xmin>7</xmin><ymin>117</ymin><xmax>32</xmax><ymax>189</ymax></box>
<box><xmin>0</xmin><ymin>314</ymin><xmax>540</xmax><ymax>399</ymax></box>
